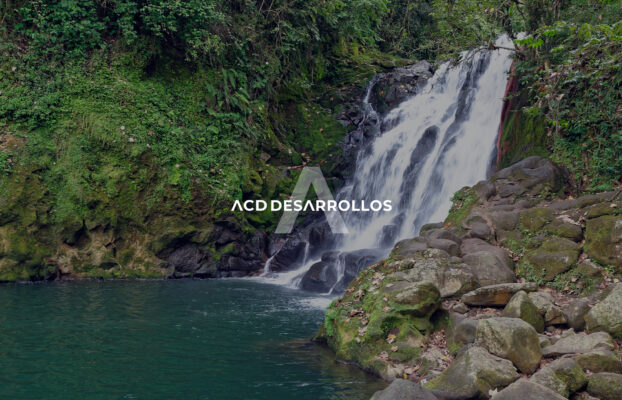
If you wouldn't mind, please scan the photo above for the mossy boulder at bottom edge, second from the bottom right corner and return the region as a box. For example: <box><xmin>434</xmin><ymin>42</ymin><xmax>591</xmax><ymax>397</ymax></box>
<box><xmin>530</xmin><ymin>358</ymin><xmax>587</xmax><ymax>397</ymax></box>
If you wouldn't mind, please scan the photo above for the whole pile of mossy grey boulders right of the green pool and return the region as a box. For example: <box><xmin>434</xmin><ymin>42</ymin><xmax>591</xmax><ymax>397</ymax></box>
<box><xmin>317</xmin><ymin>157</ymin><xmax>622</xmax><ymax>399</ymax></box>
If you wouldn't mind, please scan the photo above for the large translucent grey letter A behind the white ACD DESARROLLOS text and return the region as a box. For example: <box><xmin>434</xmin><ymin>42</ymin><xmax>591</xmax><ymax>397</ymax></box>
<box><xmin>275</xmin><ymin>167</ymin><xmax>348</xmax><ymax>233</ymax></box>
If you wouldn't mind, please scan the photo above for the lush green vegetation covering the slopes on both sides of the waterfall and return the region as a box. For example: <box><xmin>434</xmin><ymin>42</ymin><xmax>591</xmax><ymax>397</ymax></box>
<box><xmin>0</xmin><ymin>0</ymin><xmax>622</xmax><ymax>282</ymax></box>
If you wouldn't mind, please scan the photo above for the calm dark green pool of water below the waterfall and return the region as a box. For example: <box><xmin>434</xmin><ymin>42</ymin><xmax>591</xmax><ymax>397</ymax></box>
<box><xmin>0</xmin><ymin>280</ymin><xmax>384</xmax><ymax>400</ymax></box>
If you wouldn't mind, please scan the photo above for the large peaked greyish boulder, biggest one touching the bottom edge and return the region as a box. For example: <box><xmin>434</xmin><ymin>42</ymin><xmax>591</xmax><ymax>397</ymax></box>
<box><xmin>424</xmin><ymin>346</ymin><xmax>519</xmax><ymax>399</ymax></box>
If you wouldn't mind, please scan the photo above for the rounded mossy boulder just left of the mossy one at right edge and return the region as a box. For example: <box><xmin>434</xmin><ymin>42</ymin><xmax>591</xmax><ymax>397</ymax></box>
<box><xmin>525</xmin><ymin>236</ymin><xmax>579</xmax><ymax>281</ymax></box>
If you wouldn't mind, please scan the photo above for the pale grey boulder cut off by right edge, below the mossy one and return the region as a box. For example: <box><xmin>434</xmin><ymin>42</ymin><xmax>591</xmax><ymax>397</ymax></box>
<box><xmin>585</xmin><ymin>283</ymin><xmax>622</xmax><ymax>339</ymax></box>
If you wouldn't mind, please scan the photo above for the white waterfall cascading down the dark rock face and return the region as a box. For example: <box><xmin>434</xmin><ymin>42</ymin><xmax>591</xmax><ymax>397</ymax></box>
<box><xmin>258</xmin><ymin>36</ymin><xmax>512</xmax><ymax>291</ymax></box>
